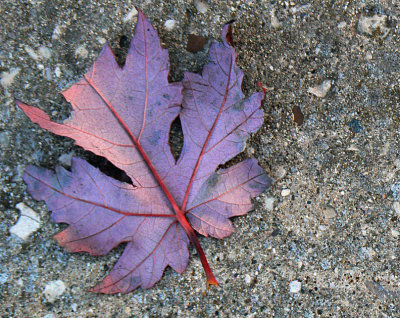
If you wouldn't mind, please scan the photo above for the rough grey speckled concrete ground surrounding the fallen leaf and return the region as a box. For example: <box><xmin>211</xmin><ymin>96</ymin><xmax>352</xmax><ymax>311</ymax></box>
<box><xmin>0</xmin><ymin>0</ymin><xmax>400</xmax><ymax>318</ymax></box>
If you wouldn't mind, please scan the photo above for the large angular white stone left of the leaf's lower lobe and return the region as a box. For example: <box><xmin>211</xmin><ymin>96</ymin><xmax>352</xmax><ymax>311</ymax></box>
<box><xmin>10</xmin><ymin>202</ymin><xmax>40</xmax><ymax>241</ymax></box>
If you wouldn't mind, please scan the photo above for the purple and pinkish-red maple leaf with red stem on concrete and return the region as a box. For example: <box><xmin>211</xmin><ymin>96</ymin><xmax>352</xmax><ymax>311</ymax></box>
<box><xmin>17</xmin><ymin>11</ymin><xmax>271</xmax><ymax>293</ymax></box>
